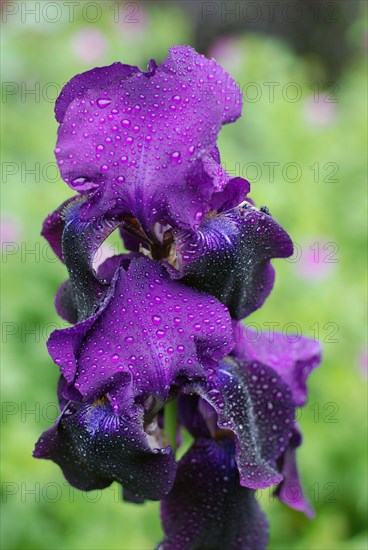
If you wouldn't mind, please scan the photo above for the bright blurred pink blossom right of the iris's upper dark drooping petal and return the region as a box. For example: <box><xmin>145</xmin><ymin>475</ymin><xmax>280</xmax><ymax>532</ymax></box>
<box><xmin>294</xmin><ymin>238</ymin><xmax>339</xmax><ymax>281</ymax></box>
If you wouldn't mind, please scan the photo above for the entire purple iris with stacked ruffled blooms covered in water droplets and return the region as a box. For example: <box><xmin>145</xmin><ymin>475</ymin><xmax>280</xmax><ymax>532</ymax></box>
<box><xmin>34</xmin><ymin>46</ymin><xmax>320</xmax><ymax>550</ymax></box>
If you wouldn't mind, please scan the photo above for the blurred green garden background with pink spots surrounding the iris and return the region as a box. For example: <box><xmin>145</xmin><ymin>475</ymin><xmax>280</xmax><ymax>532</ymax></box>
<box><xmin>1</xmin><ymin>1</ymin><xmax>367</xmax><ymax>550</ymax></box>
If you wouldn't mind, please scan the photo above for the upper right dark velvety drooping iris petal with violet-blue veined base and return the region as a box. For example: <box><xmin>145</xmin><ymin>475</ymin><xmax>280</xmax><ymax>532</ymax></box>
<box><xmin>172</xmin><ymin>204</ymin><xmax>293</xmax><ymax>319</ymax></box>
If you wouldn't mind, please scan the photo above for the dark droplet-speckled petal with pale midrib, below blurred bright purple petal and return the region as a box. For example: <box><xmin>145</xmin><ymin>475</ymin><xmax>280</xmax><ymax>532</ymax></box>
<box><xmin>190</xmin><ymin>360</ymin><xmax>295</xmax><ymax>489</ymax></box>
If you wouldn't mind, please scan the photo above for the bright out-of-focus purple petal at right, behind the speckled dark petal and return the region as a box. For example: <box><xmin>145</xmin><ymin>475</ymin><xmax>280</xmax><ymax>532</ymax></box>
<box><xmin>232</xmin><ymin>323</ymin><xmax>321</xmax><ymax>406</ymax></box>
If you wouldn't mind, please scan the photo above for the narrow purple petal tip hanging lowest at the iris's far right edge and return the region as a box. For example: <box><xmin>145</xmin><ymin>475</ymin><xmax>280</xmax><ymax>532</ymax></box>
<box><xmin>275</xmin><ymin>426</ymin><xmax>314</xmax><ymax>518</ymax></box>
